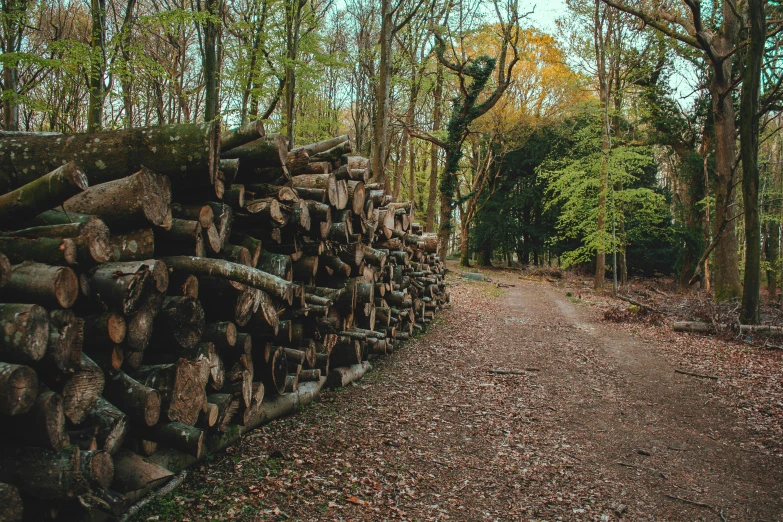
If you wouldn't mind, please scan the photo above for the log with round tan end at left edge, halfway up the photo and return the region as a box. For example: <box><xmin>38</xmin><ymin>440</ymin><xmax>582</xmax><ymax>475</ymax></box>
<box><xmin>0</xmin><ymin>262</ymin><xmax>79</xmax><ymax>308</ymax></box>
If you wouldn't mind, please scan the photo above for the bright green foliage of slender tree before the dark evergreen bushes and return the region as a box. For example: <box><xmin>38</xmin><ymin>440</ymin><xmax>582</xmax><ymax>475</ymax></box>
<box><xmin>537</xmin><ymin>102</ymin><xmax>671</xmax><ymax>268</ymax></box>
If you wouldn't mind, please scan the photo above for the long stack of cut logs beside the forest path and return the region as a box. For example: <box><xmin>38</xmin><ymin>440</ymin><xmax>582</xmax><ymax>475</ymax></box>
<box><xmin>0</xmin><ymin>122</ymin><xmax>449</xmax><ymax>520</ymax></box>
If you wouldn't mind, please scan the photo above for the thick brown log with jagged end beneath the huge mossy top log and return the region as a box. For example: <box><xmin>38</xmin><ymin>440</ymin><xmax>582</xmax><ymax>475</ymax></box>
<box><xmin>63</xmin><ymin>169</ymin><xmax>171</xmax><ymax>230</ymax></box>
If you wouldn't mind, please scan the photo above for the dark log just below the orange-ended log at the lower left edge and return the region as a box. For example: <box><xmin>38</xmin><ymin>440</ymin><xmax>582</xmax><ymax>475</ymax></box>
<box><xmin>0</xmin><ymin>391</ymin><xmax>69</xmax><ymax>448</ymax></box>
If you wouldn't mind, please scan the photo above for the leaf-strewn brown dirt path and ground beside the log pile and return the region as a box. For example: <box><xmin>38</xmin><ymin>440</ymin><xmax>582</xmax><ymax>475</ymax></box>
<box><xmin>134</xmin><ymin>267</ymin><xmax>783</xmax><ymax>521</ymax></box>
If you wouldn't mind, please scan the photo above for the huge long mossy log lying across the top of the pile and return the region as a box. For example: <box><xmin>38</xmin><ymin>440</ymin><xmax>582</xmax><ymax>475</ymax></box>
<box><xmin>0</xmin><ymin>122</ymin><xmax>220</xmax><ymax>192</ymax></box>
